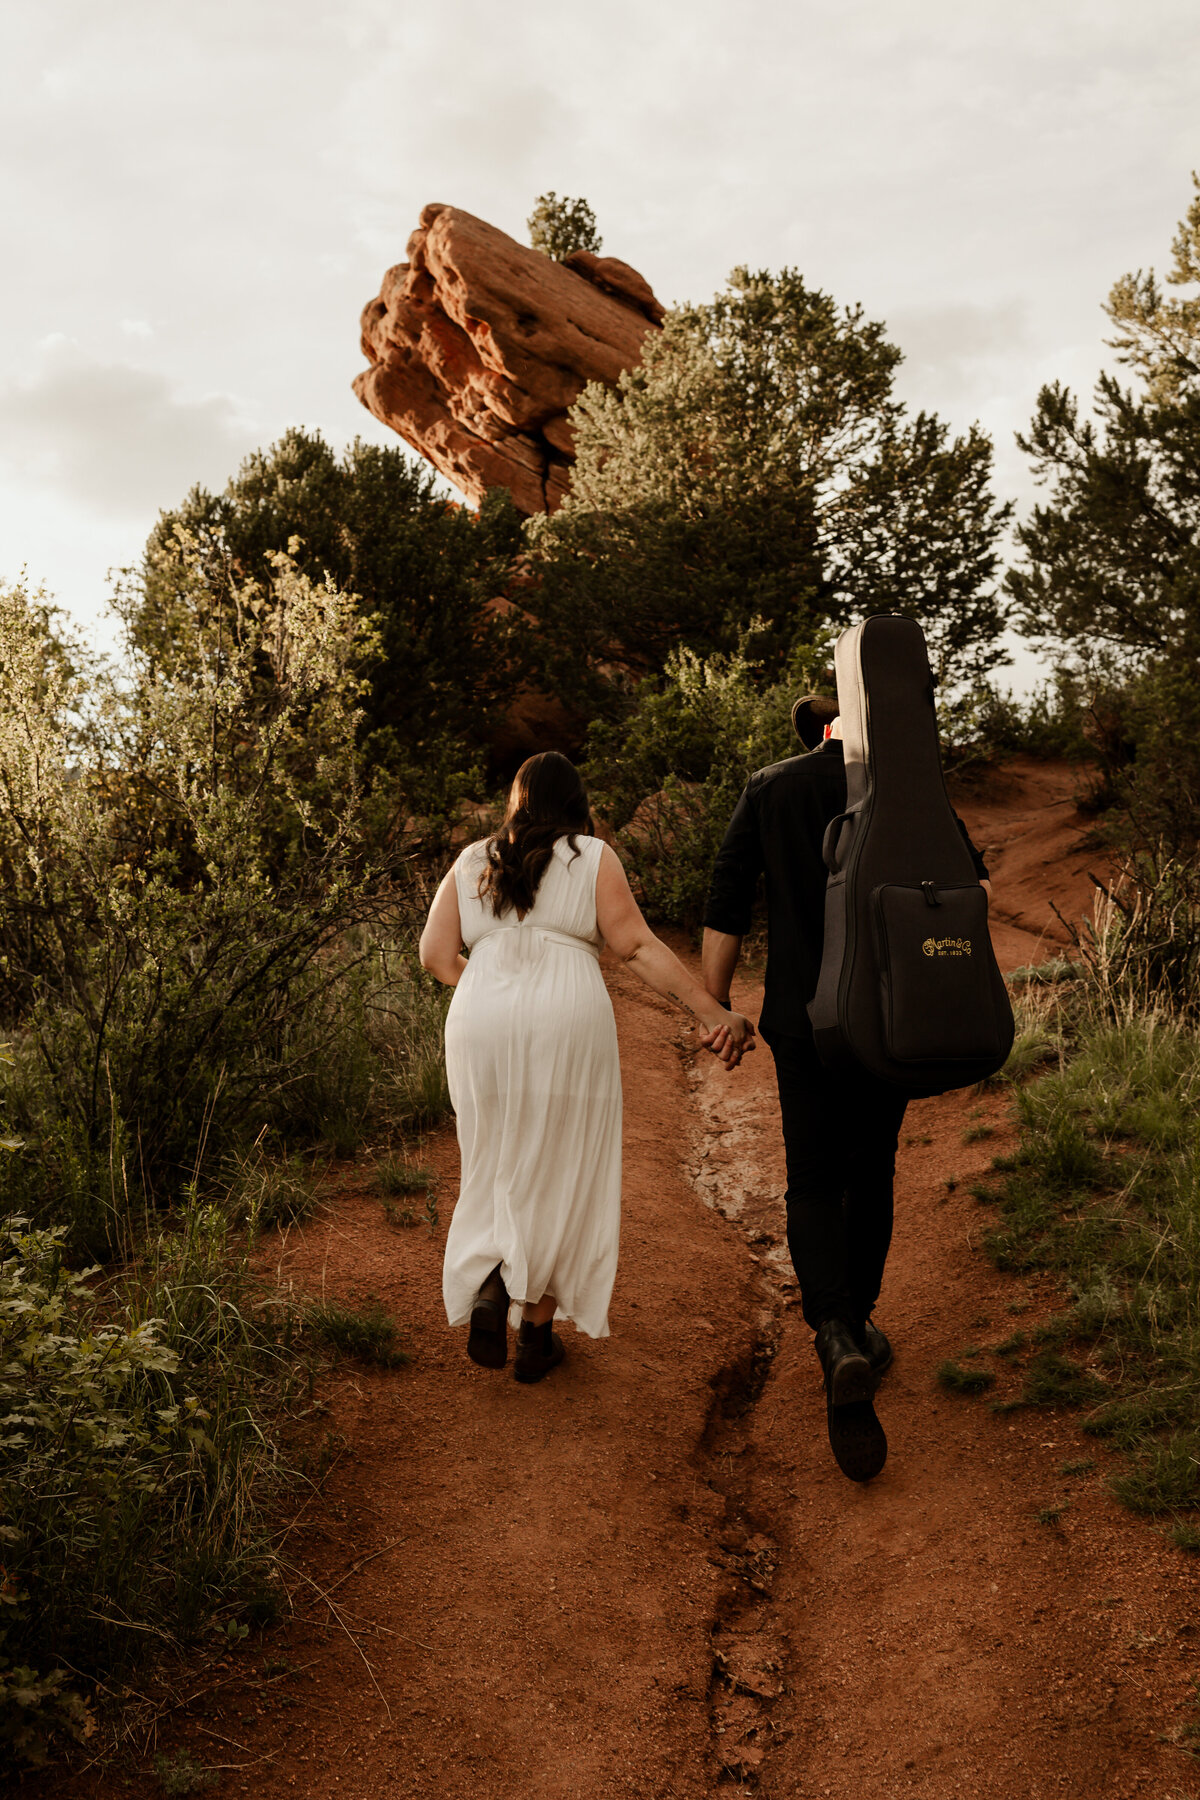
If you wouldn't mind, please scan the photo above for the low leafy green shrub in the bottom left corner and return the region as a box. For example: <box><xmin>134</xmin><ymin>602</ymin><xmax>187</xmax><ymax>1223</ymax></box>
<box><xmin>0</xmin><ymin>1206</ymin><xmax>288</xmax><ymax>1760</ymax></box>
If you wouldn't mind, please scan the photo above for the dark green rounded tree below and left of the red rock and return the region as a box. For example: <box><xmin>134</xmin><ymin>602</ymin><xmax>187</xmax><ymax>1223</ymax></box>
<box><xmin>132</xmin><ymin>430</ymin><xmax>525</xmax><ymax>814</ymax></box>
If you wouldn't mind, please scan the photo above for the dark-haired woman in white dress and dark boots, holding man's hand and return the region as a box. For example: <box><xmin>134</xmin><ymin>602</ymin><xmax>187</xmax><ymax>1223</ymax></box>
<box><xmin>421</xmin><ymin>751</ymin><xmax>754</xmax><ymax>1382</ymax></box>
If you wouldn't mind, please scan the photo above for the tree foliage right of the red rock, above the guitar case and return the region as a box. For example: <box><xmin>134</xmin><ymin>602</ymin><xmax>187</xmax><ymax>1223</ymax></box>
<box><xmin>529</xmin><ymin>268</ymin><xmax>1007</xmax><ymax>704</ymax></box>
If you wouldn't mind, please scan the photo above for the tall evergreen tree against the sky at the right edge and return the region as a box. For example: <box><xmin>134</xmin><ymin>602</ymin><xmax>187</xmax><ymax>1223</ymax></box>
<box><xmin>1007</xmin><ymin>171</ymin><xmax>1200</xmax><ymax>850</ymax></box>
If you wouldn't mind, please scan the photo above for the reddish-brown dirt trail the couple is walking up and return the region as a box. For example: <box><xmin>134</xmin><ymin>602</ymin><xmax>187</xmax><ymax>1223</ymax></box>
<box><xmin>37</xmin><ymin>763</ymin><xmax>1200</xmax><ymax>1800</ymax></box>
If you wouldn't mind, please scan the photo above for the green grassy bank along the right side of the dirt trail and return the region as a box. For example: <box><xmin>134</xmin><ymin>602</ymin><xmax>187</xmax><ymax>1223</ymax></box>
<box><xmin>977</xmin><ymin>874</ymin><xmax>1200</xmax><ymax>1543</ymax></box>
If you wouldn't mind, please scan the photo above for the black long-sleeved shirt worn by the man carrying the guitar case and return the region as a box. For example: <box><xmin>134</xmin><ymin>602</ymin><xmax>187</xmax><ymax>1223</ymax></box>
<box><xmin>703</xmin><ymin>738</ymin><xmax>988</xmax><ymax>1037</ymax></box>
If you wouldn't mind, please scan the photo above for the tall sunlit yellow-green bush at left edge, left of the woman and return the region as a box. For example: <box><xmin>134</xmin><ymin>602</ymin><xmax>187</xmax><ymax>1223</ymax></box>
<box><xmin>0</xmin><ymin>554</ymin><xmax>376</xmax><ymax>1249</ymax></box>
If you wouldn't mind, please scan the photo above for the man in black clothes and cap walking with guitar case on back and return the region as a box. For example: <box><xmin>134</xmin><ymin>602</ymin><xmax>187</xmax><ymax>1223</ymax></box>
<box><xmin>703</xmin><ymin>695</ymin><xmax>988</xmax><ymax>1481</ymax></box>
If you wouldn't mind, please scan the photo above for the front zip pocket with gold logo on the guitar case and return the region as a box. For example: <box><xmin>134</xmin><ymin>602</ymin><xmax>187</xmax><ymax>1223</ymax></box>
<box><xmin>871</xmin><ymin>882</ymin><xmax>1007</xmax><ymax>1066</ymax></box>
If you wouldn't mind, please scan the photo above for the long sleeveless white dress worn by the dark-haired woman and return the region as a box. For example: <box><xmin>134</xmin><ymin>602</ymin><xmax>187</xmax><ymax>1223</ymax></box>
<box><xmin>443</xmin><ymin>835</ymin><xmax>621</xmax><ymax>1337</ymax></box>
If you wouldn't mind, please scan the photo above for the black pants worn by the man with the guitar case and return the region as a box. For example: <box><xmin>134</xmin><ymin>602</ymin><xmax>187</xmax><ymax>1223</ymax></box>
<box><xmin>768</xmin><ymin>1031</ymin><xmax>907</xmax><ymax>1330</ymax></box>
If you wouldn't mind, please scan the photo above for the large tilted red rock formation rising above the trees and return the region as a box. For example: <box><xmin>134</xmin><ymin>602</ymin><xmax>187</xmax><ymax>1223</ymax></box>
<box><xmin>354</xmin><ymin>205</ymin><xmax>664</xmax><ymax>513</ymax></box>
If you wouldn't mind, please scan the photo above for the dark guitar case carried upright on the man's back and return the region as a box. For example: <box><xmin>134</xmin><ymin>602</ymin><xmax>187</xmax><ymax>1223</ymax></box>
<box><xmin>808</xmin><ymin>614</ymin><xmax>1013</xmax><ymax>1096</ymax></box>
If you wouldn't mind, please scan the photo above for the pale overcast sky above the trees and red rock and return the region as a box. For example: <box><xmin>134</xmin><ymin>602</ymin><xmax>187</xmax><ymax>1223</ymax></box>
<box><xmin>0</xmin><ymin>0</ymin><xmax>1200</xmax><ymax>686</ymax></box>
